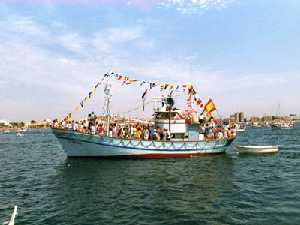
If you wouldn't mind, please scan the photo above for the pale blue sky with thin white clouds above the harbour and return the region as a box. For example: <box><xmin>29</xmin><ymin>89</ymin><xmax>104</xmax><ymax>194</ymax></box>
<box><xmin>0</xmin><ymin>0</ymin><xmax>300</xmax><ymax>120</ymax></box>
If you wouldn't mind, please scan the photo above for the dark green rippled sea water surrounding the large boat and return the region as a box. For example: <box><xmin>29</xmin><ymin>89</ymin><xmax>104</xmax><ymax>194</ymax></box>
<box><xmin>0</xmin><ymin>125</ymin><xmax>300</xmax><ymax>225</ymax></box>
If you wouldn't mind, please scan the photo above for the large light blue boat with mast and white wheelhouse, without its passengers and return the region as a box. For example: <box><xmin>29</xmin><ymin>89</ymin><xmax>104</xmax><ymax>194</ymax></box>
<box><xmin>52</xmin><ymin>72</ymin><xmax>235</xmax><ymax>158</ymax></box>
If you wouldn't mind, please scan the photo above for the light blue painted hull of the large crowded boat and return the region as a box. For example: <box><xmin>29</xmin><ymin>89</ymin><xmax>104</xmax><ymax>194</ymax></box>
<box><xmin>52</xmin><ymin>129</ymin><xmax>233</xmax><ymax>158</ymax></box>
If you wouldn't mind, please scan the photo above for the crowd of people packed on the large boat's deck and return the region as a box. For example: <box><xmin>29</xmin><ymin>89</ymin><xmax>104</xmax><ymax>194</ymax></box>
<box><xmin>52</xmin><ymin>112</ymin><xmax>236</xmax><ymax>141</ymax></box>
